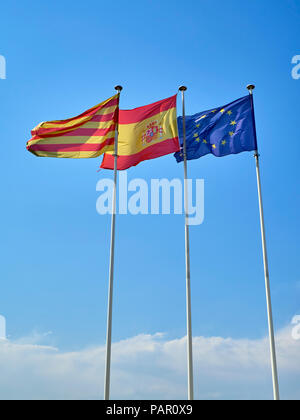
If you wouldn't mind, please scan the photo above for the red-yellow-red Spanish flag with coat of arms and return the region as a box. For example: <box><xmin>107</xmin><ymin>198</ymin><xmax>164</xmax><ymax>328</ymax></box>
<box><xmin>101</xmin><ymin>95</ymin><xmax>180</xmax><ymax>170</ymax></box>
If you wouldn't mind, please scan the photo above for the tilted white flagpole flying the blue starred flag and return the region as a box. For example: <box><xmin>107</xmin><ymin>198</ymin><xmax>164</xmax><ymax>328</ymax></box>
<box><xmin>247</xmin><ymin>85</ymin><xmax>279</xmax><ymax>400</ymax></box>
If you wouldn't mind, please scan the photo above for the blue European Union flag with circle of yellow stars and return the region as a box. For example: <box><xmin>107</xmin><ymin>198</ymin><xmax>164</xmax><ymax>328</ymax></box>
<box><xmin>174</xmin><ymin>95</ymin><xmax>257</xmax><ymax>162</ymax></box>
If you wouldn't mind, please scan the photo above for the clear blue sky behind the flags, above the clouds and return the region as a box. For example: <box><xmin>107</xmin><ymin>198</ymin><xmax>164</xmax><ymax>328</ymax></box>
<box><xmin>0</xmin><ymin>0</ymin><xmax>300</xmax><ymax>398</ymax></box>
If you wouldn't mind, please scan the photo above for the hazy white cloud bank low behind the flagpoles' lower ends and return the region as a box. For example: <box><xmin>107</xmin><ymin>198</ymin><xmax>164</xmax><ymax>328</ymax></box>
<box><xmin>0</xmin><ymin>327</ymin><xmax>300</xmax><ymax>399</ymax></box>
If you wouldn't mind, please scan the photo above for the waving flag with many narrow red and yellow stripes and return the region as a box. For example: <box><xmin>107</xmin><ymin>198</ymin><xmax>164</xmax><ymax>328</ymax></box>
<box><xmin>27</xmin><ymin>94</ymin><xmax>119</xmax><ymax>158</ymax></box>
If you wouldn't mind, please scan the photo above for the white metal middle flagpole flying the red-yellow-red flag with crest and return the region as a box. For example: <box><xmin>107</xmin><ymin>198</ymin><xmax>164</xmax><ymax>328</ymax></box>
<box><xmin>179</xmin><ymin>86</ymin><xmax>194</xmax><ymax>400</ymax></box>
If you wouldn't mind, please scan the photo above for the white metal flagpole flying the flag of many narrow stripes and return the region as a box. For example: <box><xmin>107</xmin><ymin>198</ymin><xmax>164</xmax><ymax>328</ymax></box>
<box><xmin>104</xmin><ymin>86</ymin><xmax>123</xmax><ymax>400</ymax></box>
